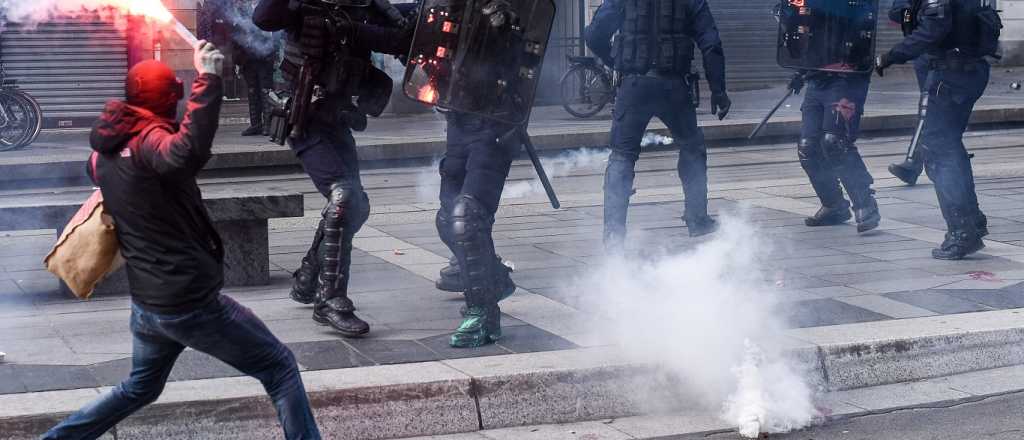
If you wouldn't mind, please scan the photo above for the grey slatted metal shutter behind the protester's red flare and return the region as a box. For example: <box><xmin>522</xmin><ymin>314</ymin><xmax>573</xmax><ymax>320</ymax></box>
<box><xmin>0</xmin><ymin>18</ymin><xmax>128</xmax><ymax>128</ymax></box>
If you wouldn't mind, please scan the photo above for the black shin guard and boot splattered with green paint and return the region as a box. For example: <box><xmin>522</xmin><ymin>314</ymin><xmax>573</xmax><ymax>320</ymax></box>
<box><xmin>451</xmin><ymin>194</ymin><xmax>507</xmax><ymax>348</ymax></box>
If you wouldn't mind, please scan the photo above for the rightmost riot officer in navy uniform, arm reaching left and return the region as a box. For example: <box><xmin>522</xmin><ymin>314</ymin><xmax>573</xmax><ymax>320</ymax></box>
<box><xmin>876</xmin><ymin>0</ymin><xmax>1002</xmax><ymax>260</ymax></box>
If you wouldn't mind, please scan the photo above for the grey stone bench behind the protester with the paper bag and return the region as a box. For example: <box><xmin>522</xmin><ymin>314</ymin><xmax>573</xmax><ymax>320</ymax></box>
<box><xmin>0</xmin><ymin>188</ymin><xmax>303</xmax><ymax>293</ymax></box>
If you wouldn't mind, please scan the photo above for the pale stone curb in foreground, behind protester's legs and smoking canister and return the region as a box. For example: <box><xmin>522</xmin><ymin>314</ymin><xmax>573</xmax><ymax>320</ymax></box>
<box><xmin>6</xmin><ymin>310</ymin><xmax>1024</xmax><ymax>439</ymax></box>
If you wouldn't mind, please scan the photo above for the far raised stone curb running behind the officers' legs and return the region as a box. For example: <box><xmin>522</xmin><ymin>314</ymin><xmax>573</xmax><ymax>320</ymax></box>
<box><xmin>8</xmin><ymin>105</ymin><xmax>1024</xmax><ymax>185</ymax></box>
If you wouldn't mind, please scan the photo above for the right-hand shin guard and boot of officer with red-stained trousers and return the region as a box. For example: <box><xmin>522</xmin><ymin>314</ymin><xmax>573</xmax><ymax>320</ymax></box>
<box><xmin>821</xmin><ymin>130</ymin><xmax>882</xmax><ymax>232</ymax></box>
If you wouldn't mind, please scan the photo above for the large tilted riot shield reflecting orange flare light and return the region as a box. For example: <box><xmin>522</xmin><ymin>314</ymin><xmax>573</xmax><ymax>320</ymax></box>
<box><xmin>402</xmin><ymin>0</ymin><xmax>555</xmax><ymax>124</ymax></box>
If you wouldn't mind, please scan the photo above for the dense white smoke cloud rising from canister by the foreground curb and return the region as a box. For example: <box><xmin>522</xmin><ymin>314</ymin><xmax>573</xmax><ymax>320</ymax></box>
<box><xmin>577</xmin><ymin>217</ymin><xmax>819</xmax><ymax>436</ymax></box>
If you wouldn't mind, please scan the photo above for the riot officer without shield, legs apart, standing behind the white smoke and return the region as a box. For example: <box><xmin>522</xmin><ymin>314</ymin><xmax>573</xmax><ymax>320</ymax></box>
<box><xmin>586</xmin><ymin>0</ymin><xmax>731</xmax><ymax>252</ymax></box>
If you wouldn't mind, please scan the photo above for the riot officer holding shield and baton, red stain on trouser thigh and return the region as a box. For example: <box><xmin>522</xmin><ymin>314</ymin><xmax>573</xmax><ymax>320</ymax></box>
<box><xmin>779</xmin><ymin>2</ymin><xmax>881</xmax><ymax>232</ymax></box>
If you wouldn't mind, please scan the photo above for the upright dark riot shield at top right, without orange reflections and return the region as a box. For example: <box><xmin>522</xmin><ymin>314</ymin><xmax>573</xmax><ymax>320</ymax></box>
<box><xmin>777</xmin><ymin>0</ymin><xmax>879</xmax><ymax>73</ymax></box>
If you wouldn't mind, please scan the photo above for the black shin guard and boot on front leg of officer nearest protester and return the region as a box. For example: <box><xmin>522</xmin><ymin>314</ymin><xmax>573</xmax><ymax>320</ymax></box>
<box><xmin>313</xmin><ymin>183</ymin><xmax>370</xmax><ymax>337</ymax></box>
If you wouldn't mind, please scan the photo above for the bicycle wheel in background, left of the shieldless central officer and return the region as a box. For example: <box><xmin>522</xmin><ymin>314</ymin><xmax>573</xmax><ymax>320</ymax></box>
<box><xmin>559</xmin><ymin>55</ymin><xmax>615</xmax><ymax>118</ymax></box>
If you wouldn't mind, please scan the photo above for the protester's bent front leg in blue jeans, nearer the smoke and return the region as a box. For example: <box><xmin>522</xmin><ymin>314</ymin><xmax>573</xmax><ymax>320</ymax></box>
<box><xmin>158</xmin><ymin>295</ymin><xmax>321</xmax><ymax>440</ymax></box>
